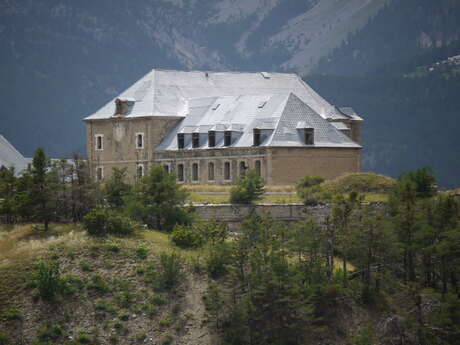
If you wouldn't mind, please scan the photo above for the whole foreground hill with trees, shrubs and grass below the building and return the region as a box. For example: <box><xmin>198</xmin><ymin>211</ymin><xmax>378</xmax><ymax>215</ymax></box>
<box><xmin>0</xmin><ymin>148</ymin><xmax>460</xmax><ymax>345</ymax></box>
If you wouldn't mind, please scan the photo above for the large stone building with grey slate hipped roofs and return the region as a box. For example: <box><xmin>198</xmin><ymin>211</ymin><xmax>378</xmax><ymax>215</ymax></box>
<box><xmin>84</xmin><ymin>69</ymin><xmax>362</xmax><ymax>185</ymax></box>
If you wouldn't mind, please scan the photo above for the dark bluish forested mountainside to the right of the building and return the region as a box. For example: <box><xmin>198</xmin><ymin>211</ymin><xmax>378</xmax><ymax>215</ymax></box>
<box><xmin>306</xmin><ymin>0</ymin><xmax>460</xmax><ymax>186</ymax></box>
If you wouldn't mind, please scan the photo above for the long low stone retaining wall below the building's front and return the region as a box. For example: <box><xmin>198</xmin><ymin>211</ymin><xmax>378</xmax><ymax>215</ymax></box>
<box><xmin>191</xmin><ymin>204</ymin><xmax>331</xmax><ymax>229</ymax></box>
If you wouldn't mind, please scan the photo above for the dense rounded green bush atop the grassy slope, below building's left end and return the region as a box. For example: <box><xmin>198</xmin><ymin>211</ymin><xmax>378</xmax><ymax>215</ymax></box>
<box><xmin>83</xmin><ymin>208</ymin><xmax>133</xmax><ymax>236</ymax></box>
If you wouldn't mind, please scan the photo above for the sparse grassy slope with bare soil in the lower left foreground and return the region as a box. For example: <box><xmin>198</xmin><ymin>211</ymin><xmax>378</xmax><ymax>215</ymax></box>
<box><xmin>0</xmin><ymin>225</ymin><xmax>217</xmax><ymax>345</ymax></box>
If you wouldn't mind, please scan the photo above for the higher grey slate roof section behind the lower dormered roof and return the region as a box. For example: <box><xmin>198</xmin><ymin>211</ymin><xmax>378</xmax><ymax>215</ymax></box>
<box><xmin>85</xmin><ymin>69</ymin><xmax>335</xmax><ymax>120</ymax></box>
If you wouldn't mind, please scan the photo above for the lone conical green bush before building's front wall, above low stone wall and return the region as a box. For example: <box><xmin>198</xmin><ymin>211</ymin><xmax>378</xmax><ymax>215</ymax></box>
<box><xmin>230</xmin><ymin>170</ymin><xmax>265</xmax><ymax>204</ymax></box>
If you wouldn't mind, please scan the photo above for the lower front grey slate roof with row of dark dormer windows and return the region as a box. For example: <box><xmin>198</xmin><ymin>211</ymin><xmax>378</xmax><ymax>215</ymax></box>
<box><xmin>155</xmin><ymin>93</ymin><xmax>361</xmax><ymax>150</ymax></box>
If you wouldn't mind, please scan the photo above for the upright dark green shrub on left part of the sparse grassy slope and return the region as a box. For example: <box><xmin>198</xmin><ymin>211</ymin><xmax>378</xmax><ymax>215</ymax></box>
<box><xmin>35</xmin><ymin>261</ymin><xmax>62</xmax><ymax>301</ymax></box>
